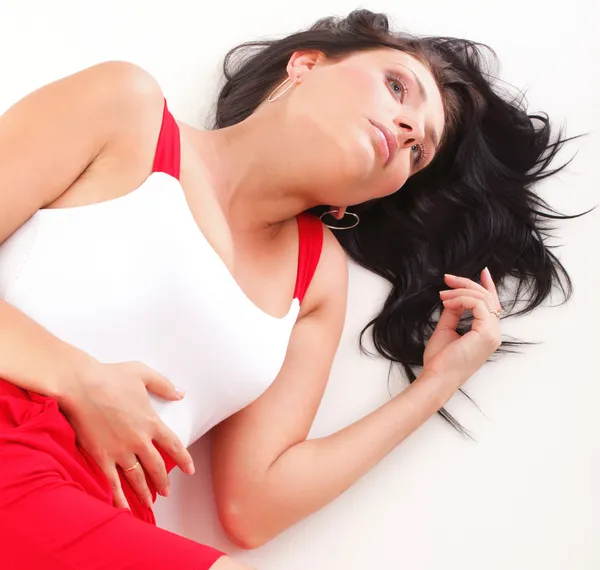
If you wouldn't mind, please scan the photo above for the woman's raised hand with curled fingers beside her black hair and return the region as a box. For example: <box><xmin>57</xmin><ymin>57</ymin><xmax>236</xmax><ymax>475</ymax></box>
<box><xmin>423</xmin><ymin>268</ymin><xmax>502</xmax><ymax>387</ymax></box>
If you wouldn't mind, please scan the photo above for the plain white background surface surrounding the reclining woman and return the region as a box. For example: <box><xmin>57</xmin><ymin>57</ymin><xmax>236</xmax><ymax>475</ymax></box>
<box><xmin>0</xmin><ymin>0</ymin><xmax>600</xmax><ymax>570</ymax></box>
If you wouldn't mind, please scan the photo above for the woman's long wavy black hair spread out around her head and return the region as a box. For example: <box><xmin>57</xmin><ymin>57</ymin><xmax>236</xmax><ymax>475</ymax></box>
<box><xmin>214</xmin><ymin>10</ymin><xmax>573</xmax><ymax>433</ymax></box>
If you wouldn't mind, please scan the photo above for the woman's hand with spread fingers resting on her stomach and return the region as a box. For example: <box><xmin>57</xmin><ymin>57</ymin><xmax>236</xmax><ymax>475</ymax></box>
<box><xmin>58</xmin><ymin>360</ymin><xmax>194</xmax><ymax>508</ymax></box>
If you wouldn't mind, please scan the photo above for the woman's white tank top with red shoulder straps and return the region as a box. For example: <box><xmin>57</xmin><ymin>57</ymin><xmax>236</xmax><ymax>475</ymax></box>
<box><xmin>0</xmin><ymin>102</ymin><xmax>323</xmax><ymax>445</ymax></box>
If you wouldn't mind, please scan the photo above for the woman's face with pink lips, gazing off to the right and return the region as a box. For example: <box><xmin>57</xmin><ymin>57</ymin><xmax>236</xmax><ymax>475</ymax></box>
<box><xmin>282</xmin><ymin>48</ymin><xmax>444</xmax><ymax>207</ymax></box>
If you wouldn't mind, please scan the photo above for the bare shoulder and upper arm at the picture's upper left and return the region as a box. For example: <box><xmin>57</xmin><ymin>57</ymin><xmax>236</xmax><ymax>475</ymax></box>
<box><xmin>0</xmin><ymin>61</ymin><xmax>164</xmax><ymax>242</ymax></box>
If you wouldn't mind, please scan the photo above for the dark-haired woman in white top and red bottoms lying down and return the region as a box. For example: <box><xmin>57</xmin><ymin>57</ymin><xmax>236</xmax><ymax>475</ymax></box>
<box><xmin>0</xmin><ymin>10</ymin><xmax>569</xmax><ymax>570</ymax></box>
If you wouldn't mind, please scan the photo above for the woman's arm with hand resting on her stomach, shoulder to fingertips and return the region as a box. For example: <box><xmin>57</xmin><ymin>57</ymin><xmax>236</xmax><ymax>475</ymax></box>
<box><xmin>0</xmin><ymin>62</ymin><xmax>193</xmax><ymax>507</ymax></box>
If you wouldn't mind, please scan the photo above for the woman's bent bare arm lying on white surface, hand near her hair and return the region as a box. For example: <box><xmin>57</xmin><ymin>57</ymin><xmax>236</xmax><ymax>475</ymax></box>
<box><xmin>212</xmin><ymin>232</ymin><xmax>499</xmax><ymax>548</ymax></box>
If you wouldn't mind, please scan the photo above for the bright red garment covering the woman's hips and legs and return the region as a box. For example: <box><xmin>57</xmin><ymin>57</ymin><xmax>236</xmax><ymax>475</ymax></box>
<box><xmin>0</xmin><ymin>379</ymin><xmax>223</xmax><ymax>570</ymax></box>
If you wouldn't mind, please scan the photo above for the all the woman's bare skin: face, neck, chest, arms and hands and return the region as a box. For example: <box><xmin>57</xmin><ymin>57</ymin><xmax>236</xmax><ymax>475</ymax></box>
<box><xmin>0</xmin><ymin>49</ymin><xmax>499</xmax><ymax>570</ymax></box>
